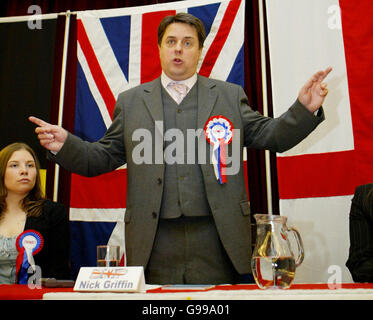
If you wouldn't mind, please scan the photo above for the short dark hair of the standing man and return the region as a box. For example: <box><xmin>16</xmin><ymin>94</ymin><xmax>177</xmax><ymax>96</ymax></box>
<box><xmin>158</xmin><ymin>12</ymin><xmax>206</xmax><ymax>48</ymax></box>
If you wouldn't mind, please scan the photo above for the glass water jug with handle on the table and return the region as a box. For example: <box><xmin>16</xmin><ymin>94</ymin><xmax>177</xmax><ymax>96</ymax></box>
<box><xmin>251</xmin><ymin>214</ymin><xmax>304</xmax><ymax>289</ymax></box>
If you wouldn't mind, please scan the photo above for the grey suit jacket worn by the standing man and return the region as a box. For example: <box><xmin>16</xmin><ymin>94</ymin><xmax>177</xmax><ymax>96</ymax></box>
<box><xmin>51</xmin><ymin>76</ymin><xmax>324</xmax><ymax>274</ymax></box>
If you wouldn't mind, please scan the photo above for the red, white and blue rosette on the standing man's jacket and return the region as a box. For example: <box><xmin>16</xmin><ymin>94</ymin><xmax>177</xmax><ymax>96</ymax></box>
<box><xmin>204</xmin><ymin>115</ymin><xmax>234</xmax><ymax>184</ymax></box>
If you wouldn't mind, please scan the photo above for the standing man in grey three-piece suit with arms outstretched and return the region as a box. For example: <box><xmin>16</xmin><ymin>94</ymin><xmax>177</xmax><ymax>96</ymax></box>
<box><xmin>30</xmin><ymin>13</ymin><xmax>331</xmax><ymax>284</ymax></box>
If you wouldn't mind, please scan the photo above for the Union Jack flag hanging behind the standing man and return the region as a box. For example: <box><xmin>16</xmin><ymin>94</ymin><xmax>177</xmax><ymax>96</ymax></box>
<box><xmin>70</xmin><ymin>0</ymin><xmax>246</xmax><ymax>273</ymax></box>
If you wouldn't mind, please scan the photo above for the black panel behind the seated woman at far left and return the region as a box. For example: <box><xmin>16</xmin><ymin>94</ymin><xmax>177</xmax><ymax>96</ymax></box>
<box><xmin>0</xmin><ymin>15</ymin><xmax>57</xmax><ymax>169</ymax></box>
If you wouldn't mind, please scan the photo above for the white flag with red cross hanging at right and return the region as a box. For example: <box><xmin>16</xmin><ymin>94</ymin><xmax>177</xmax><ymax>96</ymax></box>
<box><xmin>266</xmin><ymin>0</ymin><xmax>373</xmax><ymax>282</ymax></box>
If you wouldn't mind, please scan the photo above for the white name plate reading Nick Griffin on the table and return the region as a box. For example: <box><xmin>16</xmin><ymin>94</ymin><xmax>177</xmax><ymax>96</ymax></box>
<box><xmin>74</xmin><ymin>267</ymin><xmax>146</xmax><ymax>292</ymax></box>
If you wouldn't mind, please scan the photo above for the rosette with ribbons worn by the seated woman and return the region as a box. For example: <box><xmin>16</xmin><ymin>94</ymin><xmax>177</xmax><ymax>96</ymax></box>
<box><xmin>16</xmin><ymin>229</ymin><xmax>44</xmax><ymax>284</ymax></box>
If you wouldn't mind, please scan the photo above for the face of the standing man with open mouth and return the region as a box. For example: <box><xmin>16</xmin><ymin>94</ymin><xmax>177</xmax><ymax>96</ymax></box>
<box><xmin>158</xmin><ymin>22</ymin><xmax>202</xmax><ymax>81</ymax></box>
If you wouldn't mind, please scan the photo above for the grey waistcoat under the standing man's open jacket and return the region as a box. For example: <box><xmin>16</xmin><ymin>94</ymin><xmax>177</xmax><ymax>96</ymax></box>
<box><xmin>160</xmin><ymin>83</ymin><xmax>211</xmax><ymax>219</ymax></box>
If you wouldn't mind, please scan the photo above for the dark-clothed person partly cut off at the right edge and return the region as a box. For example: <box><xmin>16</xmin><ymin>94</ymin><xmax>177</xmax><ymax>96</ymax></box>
<box><xmin>346</xmin><ymin>183</ymin><xmax>373</xmax><ymax>282</ymax></box>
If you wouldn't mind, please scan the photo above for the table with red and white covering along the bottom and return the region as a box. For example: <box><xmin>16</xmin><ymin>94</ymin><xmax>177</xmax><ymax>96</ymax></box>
<box><xmin>0</xmin><ymin>283</ymin><xmax>373</xmax><ymax>301</ymax></box>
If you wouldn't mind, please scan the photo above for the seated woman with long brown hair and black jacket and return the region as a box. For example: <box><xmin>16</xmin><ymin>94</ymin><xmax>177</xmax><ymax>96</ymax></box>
<box><xmin>0</xmin><ymin>143</ymin><xmax>71</xmax><ymax>284</ymax></box>
